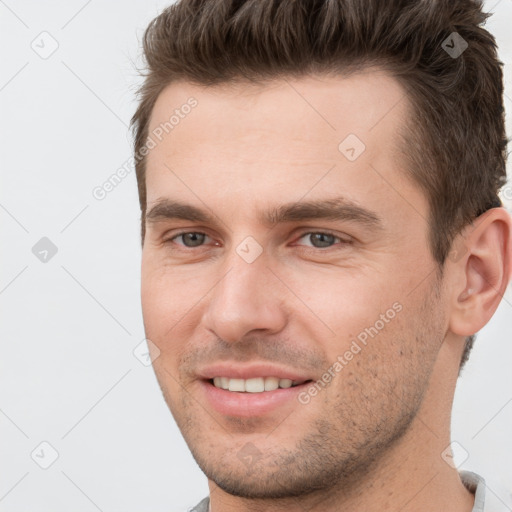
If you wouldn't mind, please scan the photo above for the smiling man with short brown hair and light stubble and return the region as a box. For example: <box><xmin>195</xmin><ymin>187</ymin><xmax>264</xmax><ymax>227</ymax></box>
<box><xmin>133</xmin><ymin>0</ymin><xmax>512</xmax><ymax>512</ymax></box>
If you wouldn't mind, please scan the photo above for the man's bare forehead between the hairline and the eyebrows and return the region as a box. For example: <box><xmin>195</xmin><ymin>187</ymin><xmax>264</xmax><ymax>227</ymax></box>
<box><xmin>146</xmin><ymin>69</ymin><xmax>424</xmax><ymax>228</ymax></box>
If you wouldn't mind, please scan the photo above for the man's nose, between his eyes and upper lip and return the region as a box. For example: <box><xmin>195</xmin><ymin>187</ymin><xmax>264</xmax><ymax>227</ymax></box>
<box><xmin>203</xmin><ymin>254</ymin><xmax>286</xmax><ymax>343</ymax></box>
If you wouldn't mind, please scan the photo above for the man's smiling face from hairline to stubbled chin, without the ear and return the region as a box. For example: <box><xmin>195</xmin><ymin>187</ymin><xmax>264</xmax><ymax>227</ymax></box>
<box><xmin>142</xmin><ymin>71</ymin><xmax>447</xmax><ymax>497</ymax></box>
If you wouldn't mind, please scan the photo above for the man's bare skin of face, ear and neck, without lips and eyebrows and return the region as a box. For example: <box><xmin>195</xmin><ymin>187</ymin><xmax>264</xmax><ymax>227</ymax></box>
<box><xmin>142</xmin><ymin>69</ymin><xmax>511</xmax><ymax>512</ymax></box>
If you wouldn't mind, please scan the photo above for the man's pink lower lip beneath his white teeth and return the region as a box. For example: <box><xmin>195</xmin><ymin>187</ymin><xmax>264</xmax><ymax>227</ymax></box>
<box><xmin>201</xmin><ymin>381</ymin><xmax>310</xmax><ymax>418</ymax></box>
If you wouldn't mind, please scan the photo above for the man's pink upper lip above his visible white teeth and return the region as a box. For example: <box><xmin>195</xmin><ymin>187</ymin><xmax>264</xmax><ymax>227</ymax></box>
<box><xmin>197</xmin><ymin>362</ymin><xmax>311</xmax><ymax>382</ymax></box>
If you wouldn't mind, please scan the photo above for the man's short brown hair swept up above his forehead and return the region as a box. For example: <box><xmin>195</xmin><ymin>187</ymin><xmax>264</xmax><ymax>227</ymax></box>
<box><xmin>132</xmin><ymin>0</ymin><xmax>507</xmax><ymax>368</ymax></box>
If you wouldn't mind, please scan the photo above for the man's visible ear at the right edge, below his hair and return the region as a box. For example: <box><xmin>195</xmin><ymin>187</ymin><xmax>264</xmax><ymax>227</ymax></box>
<box><xmin>448</xmin><ymin>208</ymin><xmax>512</xmax><ymax>336</ymax></box>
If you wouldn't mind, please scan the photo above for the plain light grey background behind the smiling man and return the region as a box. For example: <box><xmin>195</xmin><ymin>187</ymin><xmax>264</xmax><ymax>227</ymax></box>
<box><xmin>0</xmin><ymin>0</ymin><xmax>512</xmax><ymax>512</ymax></box>
